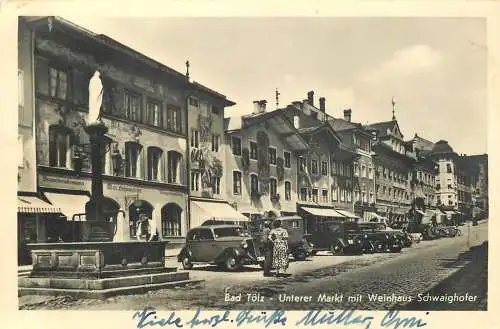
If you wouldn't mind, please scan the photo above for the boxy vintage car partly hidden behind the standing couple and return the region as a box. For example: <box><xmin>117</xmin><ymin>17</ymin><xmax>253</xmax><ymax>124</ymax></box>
<box><xmin>249</xmin><ymin>216</ymin><xmax>313</xmax><ymax>260</ymax></box>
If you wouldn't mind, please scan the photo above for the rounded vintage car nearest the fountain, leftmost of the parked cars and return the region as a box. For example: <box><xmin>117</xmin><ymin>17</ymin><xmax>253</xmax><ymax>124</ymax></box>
<box><xmin>177</xmin><ymin>224</ymin><xmax>264</xmax><ymax>271</ymax></box>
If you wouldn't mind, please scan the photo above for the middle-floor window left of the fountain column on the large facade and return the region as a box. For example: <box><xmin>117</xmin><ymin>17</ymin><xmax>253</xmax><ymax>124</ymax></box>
<box><xmin>49</xmin><ymin>126</ymin><xmax>71</xmax><ymax>168</ymax></box>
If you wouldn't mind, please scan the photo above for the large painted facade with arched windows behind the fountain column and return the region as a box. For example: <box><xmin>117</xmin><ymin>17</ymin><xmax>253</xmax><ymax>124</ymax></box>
<box><xmin>22</xmin><ymin>17</ymin><xmax>236</xmax><ymax>245</ymax></box>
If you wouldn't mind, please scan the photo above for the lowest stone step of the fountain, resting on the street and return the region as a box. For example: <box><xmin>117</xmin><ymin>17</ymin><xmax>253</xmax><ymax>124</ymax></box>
<box><xmin>18</xmin><ymin>280</ymin><xmax>203</xmax><ymax>299</ymax></box>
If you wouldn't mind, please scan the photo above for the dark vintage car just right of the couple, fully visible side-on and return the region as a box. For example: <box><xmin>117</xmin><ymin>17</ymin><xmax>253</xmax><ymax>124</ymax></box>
<box><xmin>307</xmin><ymin>220</ymin><xmax>374</xmax><ymax>255</ymax></box>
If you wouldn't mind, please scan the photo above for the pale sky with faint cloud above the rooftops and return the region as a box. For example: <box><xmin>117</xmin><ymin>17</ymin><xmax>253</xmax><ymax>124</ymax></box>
<box><xmin>63</xmin><ymin>15</ymin><xmax>488</xmax><ymax>154</ymax></box>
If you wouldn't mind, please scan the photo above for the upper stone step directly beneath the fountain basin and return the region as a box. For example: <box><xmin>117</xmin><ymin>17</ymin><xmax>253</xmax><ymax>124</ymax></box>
<box><xmin>18</xmin><ymin>272</ymin><xmax>189</xmax><ymax>290</ymax></box>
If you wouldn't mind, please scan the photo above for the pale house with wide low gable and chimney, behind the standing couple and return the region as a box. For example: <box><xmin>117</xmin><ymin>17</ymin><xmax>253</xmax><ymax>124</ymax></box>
<box><xmin>224</xmin><ymin>101</ymin><xmax>309</xmax><ymax>218</ymax></box>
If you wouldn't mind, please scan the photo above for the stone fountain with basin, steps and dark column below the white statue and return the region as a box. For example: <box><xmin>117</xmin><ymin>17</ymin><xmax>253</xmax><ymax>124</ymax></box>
<box><xmin>18</xmin><ymin>70</ymin><xmax>193</xmax><ymax>298</ymax></box>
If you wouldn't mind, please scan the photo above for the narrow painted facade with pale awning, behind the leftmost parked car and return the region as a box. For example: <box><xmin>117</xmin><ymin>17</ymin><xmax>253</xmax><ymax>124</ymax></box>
<box><xmin>187</xmin><ymin>82</ymin><xmax>241</xmax><ymax>227</ymax></box>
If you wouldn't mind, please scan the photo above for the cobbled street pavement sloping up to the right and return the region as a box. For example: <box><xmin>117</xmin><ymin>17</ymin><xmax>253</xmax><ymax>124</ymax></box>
<box><xmin>19</xmin><ymin>223</ymin><xmax>488</xmax><ymax>310</ymax></box>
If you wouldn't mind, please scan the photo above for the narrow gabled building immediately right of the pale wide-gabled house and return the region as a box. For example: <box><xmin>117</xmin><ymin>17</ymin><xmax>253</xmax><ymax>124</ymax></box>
<box><xmin>284</xmin><ymin>91</ymin><xmax>359</xmax><ymax>220</ymax></box>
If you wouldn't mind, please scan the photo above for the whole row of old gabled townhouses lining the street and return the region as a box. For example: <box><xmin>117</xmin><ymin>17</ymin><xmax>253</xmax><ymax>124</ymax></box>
<box><xmin>18</xmin><ymin>17</ymin><xmax>488</xmax><ymax>264</ymax></box>
